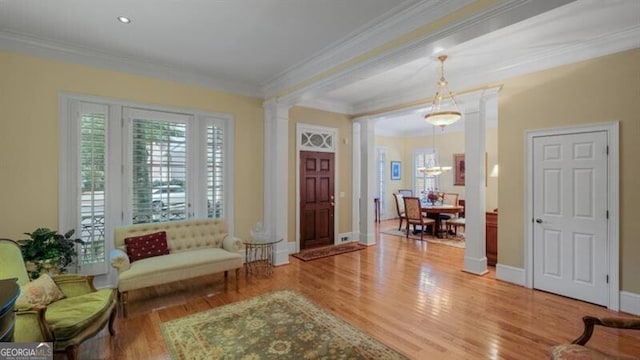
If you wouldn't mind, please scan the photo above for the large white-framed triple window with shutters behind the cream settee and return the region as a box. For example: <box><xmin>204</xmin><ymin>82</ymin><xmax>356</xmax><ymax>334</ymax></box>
<box><xmin>59</xmin><ymin>95</ymin><xmax>233</xmax><ymax>274</ymax></box>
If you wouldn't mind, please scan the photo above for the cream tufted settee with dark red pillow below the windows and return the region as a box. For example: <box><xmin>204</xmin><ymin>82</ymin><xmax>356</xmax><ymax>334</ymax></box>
<box><xmin>110</xmin><ymin>219</ymin><xmax>244</xmax><ymax>316</ymax></box>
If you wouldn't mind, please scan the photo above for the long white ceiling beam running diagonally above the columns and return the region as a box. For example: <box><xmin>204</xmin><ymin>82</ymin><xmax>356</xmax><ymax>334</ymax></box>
<box><xmin>272</xmin><ymin>0</ymin><xmax>572</xmax><ymax>109</ymax></box>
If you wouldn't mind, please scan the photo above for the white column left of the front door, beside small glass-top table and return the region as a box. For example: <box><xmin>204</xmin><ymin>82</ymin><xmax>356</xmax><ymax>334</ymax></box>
<box><xmin>263</xmin><ymin>99</ymin><xmax>289</xmax><ymax>265</ymax></box>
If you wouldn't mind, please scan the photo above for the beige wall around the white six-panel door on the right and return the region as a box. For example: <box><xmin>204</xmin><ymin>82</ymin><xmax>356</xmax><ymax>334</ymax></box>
<box><xmin>498</xmin><ymin>49</ymin><xmax>640</xmax><ymax>293</ymax></box>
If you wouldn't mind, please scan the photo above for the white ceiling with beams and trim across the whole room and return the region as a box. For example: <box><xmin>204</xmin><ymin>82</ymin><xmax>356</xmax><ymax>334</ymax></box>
<box><xmin>0</xmin><ymin>0</ymin><xmax>640</xmax><ymax>134</ymax></box>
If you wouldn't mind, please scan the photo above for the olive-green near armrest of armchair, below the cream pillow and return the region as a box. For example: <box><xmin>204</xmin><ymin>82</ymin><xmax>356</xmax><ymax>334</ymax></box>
<box><xmin>13</xmin><ymin>305</ymin><xmax>54</xmax><ymax>342</ymax></box>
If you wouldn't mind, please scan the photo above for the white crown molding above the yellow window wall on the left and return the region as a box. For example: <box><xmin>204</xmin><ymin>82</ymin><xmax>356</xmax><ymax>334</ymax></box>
<box><xmin>0</xmin><ymin>30</ymin><xmax>260</xmax><ymax>97</ymax></box>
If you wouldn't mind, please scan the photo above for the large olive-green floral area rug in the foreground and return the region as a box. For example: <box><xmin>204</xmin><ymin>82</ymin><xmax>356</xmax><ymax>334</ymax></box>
<box><xmin>161</xmin><ymin>290</ymin><xmax>407</xmax><ymax>360</ymax></box>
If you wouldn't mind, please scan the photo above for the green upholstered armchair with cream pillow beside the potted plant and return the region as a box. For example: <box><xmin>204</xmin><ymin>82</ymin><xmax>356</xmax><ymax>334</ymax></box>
<box><xmin>0</xmin><ymin>239</ymin><xmax>117</xmax><ymax>359</ymax></box>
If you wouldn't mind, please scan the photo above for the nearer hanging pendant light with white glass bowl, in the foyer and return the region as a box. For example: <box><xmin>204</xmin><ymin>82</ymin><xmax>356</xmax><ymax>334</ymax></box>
<box><xmin>424</xmin><ymin>55</ymin><xmax>462</xmax><ymax>129</ymax></box>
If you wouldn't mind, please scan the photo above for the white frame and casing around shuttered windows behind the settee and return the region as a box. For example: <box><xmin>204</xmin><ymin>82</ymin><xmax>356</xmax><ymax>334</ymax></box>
<box><xmin>58</xmin><ymin>92</ymin><xmax>235</xmax><ymax>278</ymax></box>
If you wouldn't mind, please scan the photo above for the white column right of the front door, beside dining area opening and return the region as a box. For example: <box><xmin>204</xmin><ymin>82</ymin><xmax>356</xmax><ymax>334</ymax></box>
<box><xmin>358</xmin><ymin>118</ymin><xmax>376</xmax><ymax>246</ymax></box>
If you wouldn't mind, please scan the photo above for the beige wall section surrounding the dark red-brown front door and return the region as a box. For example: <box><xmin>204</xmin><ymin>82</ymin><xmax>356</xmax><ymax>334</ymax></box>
<box><xmin>288</xmin><ymin>106</ymin><xmax>353</xmax><ymax>242</ymax></box>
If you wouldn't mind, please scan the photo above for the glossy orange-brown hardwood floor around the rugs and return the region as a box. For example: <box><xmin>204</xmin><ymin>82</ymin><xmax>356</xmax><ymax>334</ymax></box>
<box><xmin>74</xmin><ymin>221</ymin><xmax>640</xmax><ymax>360</ymax></box>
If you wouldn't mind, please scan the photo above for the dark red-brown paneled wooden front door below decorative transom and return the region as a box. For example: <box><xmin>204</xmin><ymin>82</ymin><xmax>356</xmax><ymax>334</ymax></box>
<box><xmin>300</xmin><ymin>151</ymin><xmax>335</xmax><ymax>249</ymax></box>
